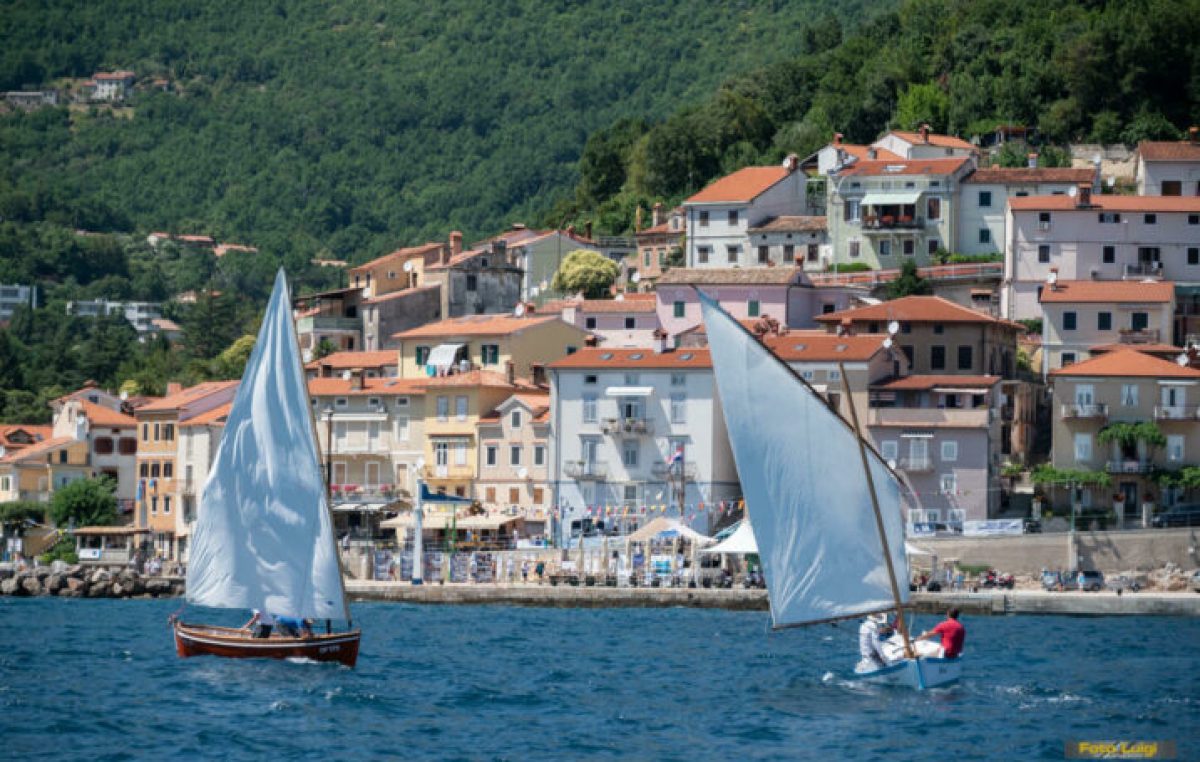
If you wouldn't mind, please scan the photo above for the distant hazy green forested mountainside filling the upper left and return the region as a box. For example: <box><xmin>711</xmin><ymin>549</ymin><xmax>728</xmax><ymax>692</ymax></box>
<box><xmin>0</xmin><ymin>0</ymin><xmax>890</xmax><ymax>260</ymax></box>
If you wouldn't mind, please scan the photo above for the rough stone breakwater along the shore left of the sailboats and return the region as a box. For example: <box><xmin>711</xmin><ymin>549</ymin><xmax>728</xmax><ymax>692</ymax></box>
<box><xmin>0</xmin><ymin>565</ymin><xmax>184</xmax><ymax>598</ymax></box>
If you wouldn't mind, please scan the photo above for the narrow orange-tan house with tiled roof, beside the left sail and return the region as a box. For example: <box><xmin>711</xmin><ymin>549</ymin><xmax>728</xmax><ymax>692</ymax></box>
<box><xmin>133</xmin><ymin>382</ymin><xmax>238</xmax><ymax>560</ymax></box>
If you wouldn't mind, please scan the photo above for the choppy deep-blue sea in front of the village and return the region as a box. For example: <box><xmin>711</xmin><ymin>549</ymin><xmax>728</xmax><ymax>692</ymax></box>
<box><xmin>0</xmin><ymin>599</ymin><xmax>1200</xmax><ymax>762</ymax></box>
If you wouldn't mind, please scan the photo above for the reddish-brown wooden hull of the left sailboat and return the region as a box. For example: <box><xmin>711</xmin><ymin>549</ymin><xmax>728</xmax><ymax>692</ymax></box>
<box><xmin>174</xmin><ymin>622</ymin><xmax>362</xmax><ymax>667</ymax></box>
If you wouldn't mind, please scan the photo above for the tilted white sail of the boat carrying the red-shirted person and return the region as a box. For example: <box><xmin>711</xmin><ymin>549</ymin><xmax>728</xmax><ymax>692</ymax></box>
<box><xmin>700</xmin><ymin>294</ymin><xmax>908</xmax><ymax>628</ymax></box>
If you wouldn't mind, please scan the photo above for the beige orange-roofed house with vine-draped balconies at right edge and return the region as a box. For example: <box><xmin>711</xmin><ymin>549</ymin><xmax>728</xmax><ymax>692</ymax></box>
<box><xmin>1050</xmin><ymin>348</ymin><xmax>1200</xmax><ymax>518</ymax></box>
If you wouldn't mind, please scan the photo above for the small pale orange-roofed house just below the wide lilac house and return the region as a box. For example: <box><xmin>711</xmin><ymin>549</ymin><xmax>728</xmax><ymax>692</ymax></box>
<box><xmin>1039</xmin><ymin>278</ymin><xmax>1182</xmax><ymax>377</ymax></box>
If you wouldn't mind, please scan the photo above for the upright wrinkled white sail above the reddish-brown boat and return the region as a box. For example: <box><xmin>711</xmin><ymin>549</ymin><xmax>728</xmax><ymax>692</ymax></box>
<box><xmin>187</xmin><ymin>270</ymin><xmax>349</xmax><ymax>619</ymax></box>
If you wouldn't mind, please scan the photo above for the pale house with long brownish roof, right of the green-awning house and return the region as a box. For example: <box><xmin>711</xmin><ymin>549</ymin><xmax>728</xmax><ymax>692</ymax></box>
<box><xmin>947</xmin><ymin>166</ymin><xmax>1100</xmax><ymax>254</ymax></box>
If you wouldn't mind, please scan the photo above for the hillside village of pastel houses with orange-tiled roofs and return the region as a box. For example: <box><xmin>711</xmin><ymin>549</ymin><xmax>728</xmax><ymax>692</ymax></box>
<box><xmin>0</xmin><ymin>128</ymin><xmax>1200</xmax><ymax>564</ymax></box>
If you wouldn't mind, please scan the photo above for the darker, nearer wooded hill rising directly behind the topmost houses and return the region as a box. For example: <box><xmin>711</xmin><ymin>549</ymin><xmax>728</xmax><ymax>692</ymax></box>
<box><xmin>561</xmin><ymin>0</ymin><xmax>1200</xmax><ymax>232</ymax></box>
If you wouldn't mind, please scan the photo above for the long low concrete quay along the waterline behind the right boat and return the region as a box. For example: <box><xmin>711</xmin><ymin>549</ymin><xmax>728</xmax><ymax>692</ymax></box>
<box><xmin>346</xmin><ymin>580</ymin><xmax>1200</xmax><ymax>617</ymax></box>
